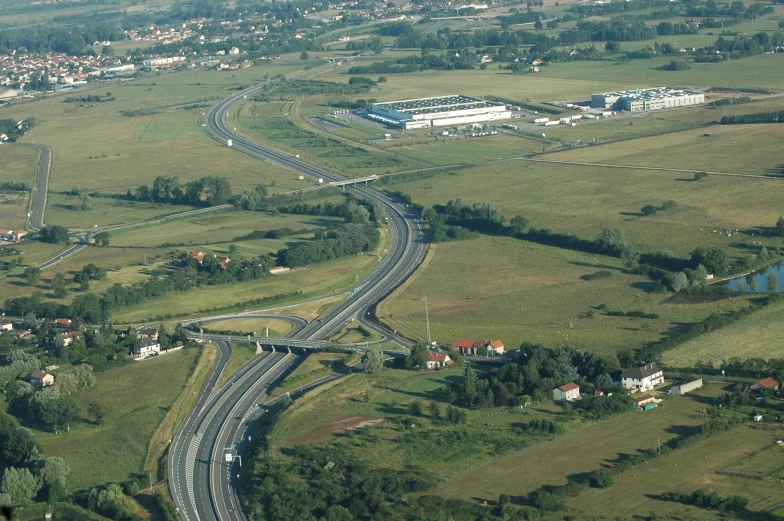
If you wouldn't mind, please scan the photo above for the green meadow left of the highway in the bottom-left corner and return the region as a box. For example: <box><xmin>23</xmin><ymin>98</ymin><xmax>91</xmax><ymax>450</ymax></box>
<box><xmin>36</xmin><ymin>349</ymin><xmax>199</xmax><ymax>490</ymax></box>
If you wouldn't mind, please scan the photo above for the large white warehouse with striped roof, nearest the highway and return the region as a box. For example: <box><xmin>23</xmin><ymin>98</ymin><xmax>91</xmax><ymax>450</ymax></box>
<box><xmin>368</xmin><ymin>94</ymin><xmax>512</xmax><ymax>129</ymax></box>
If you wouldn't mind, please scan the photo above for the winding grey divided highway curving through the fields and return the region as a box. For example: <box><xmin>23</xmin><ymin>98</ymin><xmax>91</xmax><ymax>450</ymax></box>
<box><xmin>168</xmin><ymin>64</ymin><xmax>427</xmax><ymax>521</ymax></box>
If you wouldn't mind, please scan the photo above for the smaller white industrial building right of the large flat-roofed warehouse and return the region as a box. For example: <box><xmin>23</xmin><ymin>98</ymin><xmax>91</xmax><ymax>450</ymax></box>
<box><xmin>591</xmin><ymin>87</ymin><xmax>705</xmax><ymax>112</ymax></box>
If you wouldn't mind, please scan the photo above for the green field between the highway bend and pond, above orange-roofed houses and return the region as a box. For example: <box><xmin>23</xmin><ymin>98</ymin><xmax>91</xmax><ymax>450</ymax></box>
<box><xmin>379</xmin><ymin>236</ymin><xmax>748</xmax><ymax>352</ymax></box>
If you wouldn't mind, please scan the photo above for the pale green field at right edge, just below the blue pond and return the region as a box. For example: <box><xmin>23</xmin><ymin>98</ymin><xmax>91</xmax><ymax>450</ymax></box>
<box><xmin>664</xmin><ymin>298</ymin><xmax>784</xmax><ymax>367</ymax></box>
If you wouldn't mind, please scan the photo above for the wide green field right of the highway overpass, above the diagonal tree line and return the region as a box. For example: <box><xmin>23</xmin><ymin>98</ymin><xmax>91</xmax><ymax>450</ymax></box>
<box><xmin>378</xmin><ymin>158</ymin><xmax>784</xmax><ymax>256</ymax></box>
